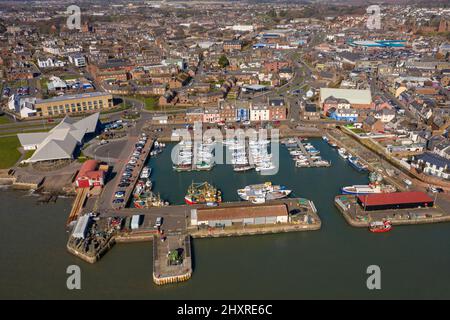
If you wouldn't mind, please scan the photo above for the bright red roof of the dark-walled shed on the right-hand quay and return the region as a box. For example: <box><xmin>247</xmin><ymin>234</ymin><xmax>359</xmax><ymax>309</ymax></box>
<box><xmin>358</xmin><ymin>191</ymin><xmax>433</xmax><ymax>206</ymax></box>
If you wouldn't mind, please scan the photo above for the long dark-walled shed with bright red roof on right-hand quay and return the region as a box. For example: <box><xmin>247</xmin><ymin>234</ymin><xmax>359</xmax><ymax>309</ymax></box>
<box><xmin>358</xmin><ymin>191</ymin><xmax>434</xmax><ymax>211</ymax></box>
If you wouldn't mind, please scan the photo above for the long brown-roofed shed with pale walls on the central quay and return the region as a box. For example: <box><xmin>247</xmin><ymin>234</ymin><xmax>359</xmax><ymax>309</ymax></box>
<box><xmin>191</xmin><ymin>204</ymin><xmax>289</xmax><ymax>227</ymax></box>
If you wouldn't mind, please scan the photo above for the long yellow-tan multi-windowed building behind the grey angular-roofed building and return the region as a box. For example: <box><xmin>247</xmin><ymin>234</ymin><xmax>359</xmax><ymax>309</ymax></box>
<box><xmin>34</xmin><ymin>92</ymin><xmax>113</xmax><ymax>117</ymax></box>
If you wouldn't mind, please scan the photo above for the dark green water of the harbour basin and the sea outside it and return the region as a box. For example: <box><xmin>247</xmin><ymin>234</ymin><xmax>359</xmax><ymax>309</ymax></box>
<box><xmin>0</xmin><ymin>140</ymin><xmax>450</xmax><ymax>299</ymax></box>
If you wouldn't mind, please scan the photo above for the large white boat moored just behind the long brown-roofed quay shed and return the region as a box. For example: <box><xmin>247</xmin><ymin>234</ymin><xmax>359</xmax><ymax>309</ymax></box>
<box><xmin>237</xmin><ymin>182</ymin><xmax>292</xmax><ymax>201</ymax></box>
